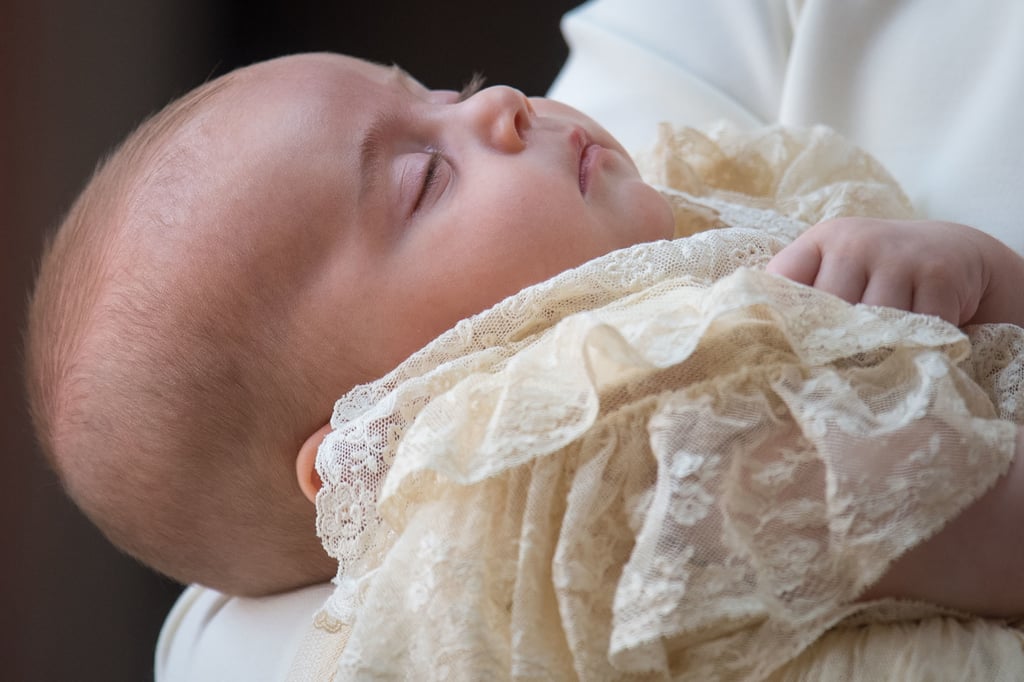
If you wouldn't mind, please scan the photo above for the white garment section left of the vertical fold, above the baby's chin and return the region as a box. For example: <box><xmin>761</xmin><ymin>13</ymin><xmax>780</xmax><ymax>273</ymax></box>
<box><xmin>548</xmin><ymin>0</ymin><xmax>799</xmax><ymax>150</ymax></box>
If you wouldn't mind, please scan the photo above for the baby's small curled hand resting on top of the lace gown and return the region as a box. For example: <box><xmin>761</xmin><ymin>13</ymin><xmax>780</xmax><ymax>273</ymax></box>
<box><xmin>768</xmin><ymin>218</ymin><xmax>1024</xmax><ymax>326</ymax></box>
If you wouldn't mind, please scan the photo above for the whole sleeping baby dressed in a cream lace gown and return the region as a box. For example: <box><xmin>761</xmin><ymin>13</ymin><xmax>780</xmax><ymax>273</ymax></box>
<box><xmin>27</xmin><ymin>54</ymin><xmax>1024</xmax><ymax>679</ymax></box>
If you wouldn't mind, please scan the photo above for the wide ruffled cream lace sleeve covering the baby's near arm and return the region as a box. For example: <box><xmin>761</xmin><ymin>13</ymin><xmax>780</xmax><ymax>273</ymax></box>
<box><xmin>323</xmin><ymin>262</ymin><xmax>1016</xmax><ymax>680</ymax></box>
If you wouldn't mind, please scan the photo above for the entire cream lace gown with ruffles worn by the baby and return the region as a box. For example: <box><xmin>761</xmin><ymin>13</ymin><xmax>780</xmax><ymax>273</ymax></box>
<box><xmin>294</xmin><ymin>127</ymin><xmax>1024</xmax><ymax>681</ymax></box>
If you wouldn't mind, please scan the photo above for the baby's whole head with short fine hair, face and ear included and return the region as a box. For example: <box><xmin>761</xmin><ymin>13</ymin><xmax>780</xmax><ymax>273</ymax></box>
<box><xmin>27</xmin><ymin>54</ymin><xmax>672</xmax><ymax>594</ymax></box>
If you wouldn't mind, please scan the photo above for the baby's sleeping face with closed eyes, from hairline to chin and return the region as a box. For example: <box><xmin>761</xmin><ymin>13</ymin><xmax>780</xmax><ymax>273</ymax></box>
<box><xmin>191</xmin><ymin>54</ymin><xmax>673</xmax><ymax>380</ymax></box>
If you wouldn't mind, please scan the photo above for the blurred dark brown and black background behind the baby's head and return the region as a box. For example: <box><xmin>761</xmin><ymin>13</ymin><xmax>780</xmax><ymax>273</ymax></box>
<box><xmin>0</xmin><ymin>0</ymin><xmax>579</xmax><ymax>682</ymax></box>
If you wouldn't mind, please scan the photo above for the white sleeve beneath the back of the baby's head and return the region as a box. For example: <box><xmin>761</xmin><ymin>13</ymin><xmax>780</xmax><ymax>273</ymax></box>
<box><xmin>155</xmin><ymin>584</ymin><xmax>334</xmax><ymax>682</ymax></box>
